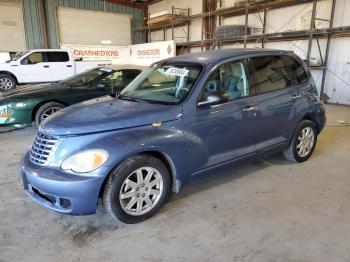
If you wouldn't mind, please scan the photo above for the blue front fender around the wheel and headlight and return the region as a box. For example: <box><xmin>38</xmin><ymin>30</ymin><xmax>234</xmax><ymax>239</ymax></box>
<box><xmin>51</xmin><ymin>120</ymin><xmax>187</xmax><ymax>192</ymax></box>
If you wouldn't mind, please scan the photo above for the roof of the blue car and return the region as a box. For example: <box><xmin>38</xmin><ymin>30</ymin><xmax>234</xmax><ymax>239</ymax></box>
<box><xmin>166</xmin><ymin>48</ymin><xmax>290</xmax><ymax>64</ymax></box>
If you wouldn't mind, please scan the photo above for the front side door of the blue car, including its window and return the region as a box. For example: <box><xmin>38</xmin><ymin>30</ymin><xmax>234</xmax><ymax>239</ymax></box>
<box><xmin>184</xmin><ymin>60</ymin><xmax>257</xmax><ymax>176</ymax></box>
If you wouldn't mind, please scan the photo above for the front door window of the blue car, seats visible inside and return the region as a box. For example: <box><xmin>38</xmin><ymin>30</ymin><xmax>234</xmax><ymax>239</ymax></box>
<box><xmin>201</xmin><ymin>61</ymin><xmax>249</xmax><ymax>101</ymax></box>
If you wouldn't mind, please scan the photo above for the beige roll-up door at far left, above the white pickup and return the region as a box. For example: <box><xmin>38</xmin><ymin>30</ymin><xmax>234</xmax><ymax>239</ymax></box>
<box><xmin>0</xmin><ymin>0</ymin><xmax>26</xmax><ymax>52</ymax></box>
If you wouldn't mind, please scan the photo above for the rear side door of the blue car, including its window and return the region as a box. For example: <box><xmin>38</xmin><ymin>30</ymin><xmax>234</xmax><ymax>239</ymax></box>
<box><xmin>249</xmin><ymin>55</ymin><xmax>298</xmax><ymax>151</ymax></box>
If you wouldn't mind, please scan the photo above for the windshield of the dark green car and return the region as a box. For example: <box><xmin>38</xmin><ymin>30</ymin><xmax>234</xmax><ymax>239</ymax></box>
<box><xmin>60</xmin><ymin>67</ymin><xmax>114</xmax><ymax>87</ymax></box>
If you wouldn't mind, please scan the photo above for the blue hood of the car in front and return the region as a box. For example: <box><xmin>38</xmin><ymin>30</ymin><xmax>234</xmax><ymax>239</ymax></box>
<box><xmin>39</xmin><ymin>96</ymin><xmax>182</xmax><ymax>135</ymax></box>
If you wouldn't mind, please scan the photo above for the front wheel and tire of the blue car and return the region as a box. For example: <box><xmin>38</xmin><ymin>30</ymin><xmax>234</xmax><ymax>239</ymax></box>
<box><xmin>103</xmin><ymin>154</ymin><xmax>170</xmax><ymax>224</ymax></box>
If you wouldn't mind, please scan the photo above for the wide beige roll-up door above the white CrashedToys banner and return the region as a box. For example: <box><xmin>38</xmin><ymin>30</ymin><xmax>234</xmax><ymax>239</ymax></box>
<box><xmin>57</xmin><ymin>7</ymin><xmax>131</xmax><ymax>45</ymax></box>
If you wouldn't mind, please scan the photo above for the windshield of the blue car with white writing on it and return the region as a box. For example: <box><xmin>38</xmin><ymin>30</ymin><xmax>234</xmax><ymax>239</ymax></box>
<box><xmin>120</xmin><ymin>63</ymin><xmax>202</xmax><ymax>104</ymax></box>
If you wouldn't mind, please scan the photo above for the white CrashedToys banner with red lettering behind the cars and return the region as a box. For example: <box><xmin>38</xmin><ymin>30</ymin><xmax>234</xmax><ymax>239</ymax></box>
<box><xmin>61</xmin><ymin>41</ymin><xmax>176</xmax><ymax>66</ymax></box>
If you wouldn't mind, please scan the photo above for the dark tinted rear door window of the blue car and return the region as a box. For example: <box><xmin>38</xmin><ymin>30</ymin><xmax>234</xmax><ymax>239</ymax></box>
<box><xmin>250</xmin><ymin>56</ymin><xmax>293</xmax><ymax>94</ymax></box>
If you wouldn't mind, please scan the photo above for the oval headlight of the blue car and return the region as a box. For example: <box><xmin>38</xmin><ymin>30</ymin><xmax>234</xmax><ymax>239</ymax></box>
<box><xmin>61</xmin><ymin>149</ymin><xmax>109</xmax><ymax>173</ymax></box>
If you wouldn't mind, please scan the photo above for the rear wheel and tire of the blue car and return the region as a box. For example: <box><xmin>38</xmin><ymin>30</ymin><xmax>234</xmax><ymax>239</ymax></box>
<box><xmin>283</xmin><ymin>120</ymin><xmax>317</xmax><ymax>163</ymax></box>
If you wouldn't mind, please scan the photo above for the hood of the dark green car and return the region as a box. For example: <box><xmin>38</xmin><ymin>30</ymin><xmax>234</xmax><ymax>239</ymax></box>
<box><xmin>0</xmin><ymin>84</ymin><xmax>64</xmax><ymax>102</ymax></box>
